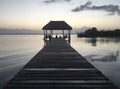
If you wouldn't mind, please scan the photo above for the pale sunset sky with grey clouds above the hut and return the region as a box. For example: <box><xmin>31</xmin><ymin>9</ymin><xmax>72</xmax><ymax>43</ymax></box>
<box><xmin>0</xmin><ymin>0</ymin><xmax>120</xmax><ymax>30</ymax></box>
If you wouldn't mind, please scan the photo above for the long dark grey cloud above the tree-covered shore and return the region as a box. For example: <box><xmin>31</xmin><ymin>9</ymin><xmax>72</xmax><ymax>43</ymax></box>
<box><xmin>72</xmin><ymin>1</ymin><xmax>120</xmax><ymax>15</ymax></box>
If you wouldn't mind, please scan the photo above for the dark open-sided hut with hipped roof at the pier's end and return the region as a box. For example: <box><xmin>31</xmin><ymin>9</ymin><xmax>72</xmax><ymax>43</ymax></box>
<box><xmin>42</xmin><ymin>21</ymin><xmax>72</xmax><ymax>41</ymax></box>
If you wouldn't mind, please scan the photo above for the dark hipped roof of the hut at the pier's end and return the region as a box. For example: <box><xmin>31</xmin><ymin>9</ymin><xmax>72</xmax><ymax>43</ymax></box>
<box><xmin>42</xmin><ymin>21</ymin><xmax>72</xmax><ymax>30</ymax></box>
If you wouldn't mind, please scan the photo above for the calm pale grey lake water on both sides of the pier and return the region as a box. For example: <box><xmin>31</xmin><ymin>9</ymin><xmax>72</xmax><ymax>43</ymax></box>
<box><xmin>0</xmin><ymin>35</ymin><xmax>120</xmax><ymax>89</ymax></box>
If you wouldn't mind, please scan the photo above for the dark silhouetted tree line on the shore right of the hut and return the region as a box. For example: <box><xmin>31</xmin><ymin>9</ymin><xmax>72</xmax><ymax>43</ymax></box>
<box><xmin>77</xmin><ymin>27</ymin><xmax>120</xmax><ymax>37</ymax></box>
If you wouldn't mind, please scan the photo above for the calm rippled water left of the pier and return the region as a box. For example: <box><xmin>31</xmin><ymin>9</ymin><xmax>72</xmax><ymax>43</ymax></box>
<box><xmin>0</xmin><ymin>35</ymin><xmax>43</xmax><ymax>89</ymax></box>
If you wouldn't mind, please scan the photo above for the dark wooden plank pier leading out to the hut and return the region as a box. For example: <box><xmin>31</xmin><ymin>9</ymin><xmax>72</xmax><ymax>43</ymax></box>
<box><xmin>4</xmin><ymin>38</ymin><xmax>118</xmax><ymax>89</ymax></box>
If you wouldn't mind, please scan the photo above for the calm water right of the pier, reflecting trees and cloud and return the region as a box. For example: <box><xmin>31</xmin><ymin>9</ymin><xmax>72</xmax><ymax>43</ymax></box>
<box><xmin>71</xmin><ymin>36</ymin><xmax>120</xmax><ymax>88</ymax></box>
